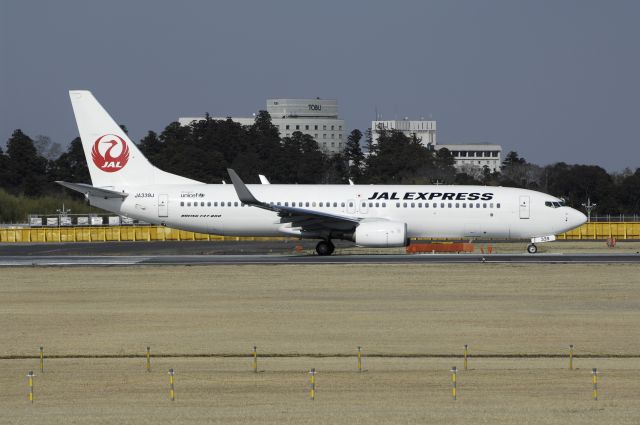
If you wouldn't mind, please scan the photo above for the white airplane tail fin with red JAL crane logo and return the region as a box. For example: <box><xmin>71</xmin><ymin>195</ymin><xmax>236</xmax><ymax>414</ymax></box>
<box><xmin>69</xmin><ymin>90</ymin><xmax>199</xmax><ymax>188</ymax></box>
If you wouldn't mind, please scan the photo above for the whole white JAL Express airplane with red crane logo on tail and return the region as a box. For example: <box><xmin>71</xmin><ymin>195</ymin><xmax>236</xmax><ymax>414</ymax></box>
<box><xmin>57</xmin><ymin>90</ymin><xmax>586</xmax><ymax>255</ymax></box>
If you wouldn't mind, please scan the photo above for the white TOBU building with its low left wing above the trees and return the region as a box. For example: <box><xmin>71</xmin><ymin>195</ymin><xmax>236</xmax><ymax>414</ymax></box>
<box><xmin>178</xmin><ymin>99</ymin><xmax>347</xmax><ymax>153</ymax></box>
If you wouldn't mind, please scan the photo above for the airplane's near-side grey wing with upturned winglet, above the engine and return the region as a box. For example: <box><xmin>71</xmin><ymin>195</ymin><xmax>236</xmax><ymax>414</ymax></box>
<box><xmin>227</xmin><ymin>168</ymin><xmax>363</xmax><ymax>231</ymax></box>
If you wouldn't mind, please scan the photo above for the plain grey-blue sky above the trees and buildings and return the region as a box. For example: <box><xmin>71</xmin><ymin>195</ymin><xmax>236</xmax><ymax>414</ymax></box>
<box><xmin>0</xmin><ymin>0</ymin><xmax>640</xmax><ymax>171</ymax></box>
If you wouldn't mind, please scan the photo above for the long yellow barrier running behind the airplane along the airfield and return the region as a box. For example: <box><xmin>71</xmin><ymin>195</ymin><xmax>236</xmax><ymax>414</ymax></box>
<box><xmin>0</xmin><ymin>222</ymin><xmax>640</xmax><ymax>242</ymax></box>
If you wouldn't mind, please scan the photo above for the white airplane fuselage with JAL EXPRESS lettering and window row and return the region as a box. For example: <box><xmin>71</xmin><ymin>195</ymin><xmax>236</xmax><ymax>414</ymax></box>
<box><xmin>90</xmin><ymin>184</ymin><xmax>585</xmax><ymax>239</ymax></box>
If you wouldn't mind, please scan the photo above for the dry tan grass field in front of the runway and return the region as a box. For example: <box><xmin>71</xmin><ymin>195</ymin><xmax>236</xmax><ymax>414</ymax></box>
<box><xmin>0</xmin><ymin>264</ymin><xmax>640</xmax><ymax>424</ymax></box>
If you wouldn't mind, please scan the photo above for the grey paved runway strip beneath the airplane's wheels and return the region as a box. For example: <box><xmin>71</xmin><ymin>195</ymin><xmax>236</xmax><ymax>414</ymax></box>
<box><xmin>0</xmin><ymin>254</ymin><xmax>640</xmax><ymax>267</ymax></box>
